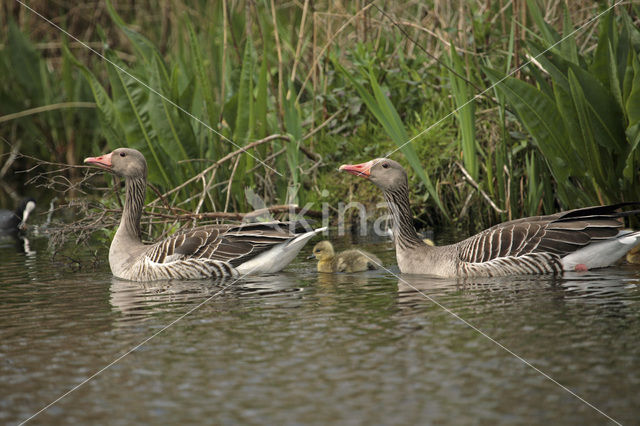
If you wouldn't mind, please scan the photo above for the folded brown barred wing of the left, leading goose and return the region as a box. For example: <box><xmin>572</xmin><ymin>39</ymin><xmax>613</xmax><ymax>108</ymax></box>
<box><xmin>147</xmin><ymin>222</ymin><xmax>304</xmax><ymax>266</ymax></box>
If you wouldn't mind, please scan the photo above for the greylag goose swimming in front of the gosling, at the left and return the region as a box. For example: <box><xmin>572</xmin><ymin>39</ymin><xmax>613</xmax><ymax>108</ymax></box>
<box><xmin>84</xmin><ymin>148</ymin><xmax>325</xmax><ymax>281</ymax></box>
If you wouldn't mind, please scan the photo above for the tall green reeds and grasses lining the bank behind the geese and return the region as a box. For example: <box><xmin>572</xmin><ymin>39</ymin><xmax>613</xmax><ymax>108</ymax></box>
<box><xmin>0</xmin><ymin>0</ymin><xmax>640</xmax><ymax>236</ymax></box>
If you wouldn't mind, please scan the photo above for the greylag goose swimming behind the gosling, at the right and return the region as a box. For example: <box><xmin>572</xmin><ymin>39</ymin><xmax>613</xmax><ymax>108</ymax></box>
<box><xmin>340</xmin><ymin>158</ymin><xmax>640</xmax><ymax>277</ymax></box>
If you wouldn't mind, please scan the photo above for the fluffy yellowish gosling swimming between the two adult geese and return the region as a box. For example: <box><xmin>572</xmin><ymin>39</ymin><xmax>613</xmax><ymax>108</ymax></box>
<box><xmin>308</xmin><ymin>241</ymin><xmax>382</xmax><ymax>272</ymax></box>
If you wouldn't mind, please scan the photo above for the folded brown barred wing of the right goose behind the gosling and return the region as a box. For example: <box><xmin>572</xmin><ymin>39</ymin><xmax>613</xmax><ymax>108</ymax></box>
<box><xmin>458</xmin><ymin>203</ymin><xmax>638</xmax><ymax>263</ymax></box>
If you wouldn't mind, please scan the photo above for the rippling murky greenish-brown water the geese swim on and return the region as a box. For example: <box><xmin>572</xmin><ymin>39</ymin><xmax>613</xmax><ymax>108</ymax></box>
<box><xmin>0</xmin><ymin>235</ymin><xmax>640</xmax><ymax>425</ymax></box>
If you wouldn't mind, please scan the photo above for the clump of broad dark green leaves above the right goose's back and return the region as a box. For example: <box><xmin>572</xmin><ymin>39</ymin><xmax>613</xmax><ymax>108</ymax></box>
<box><xmin>487</xmin><ymin>2</ymin><xmax>640</xmax><ymax>208</ymax></box>
